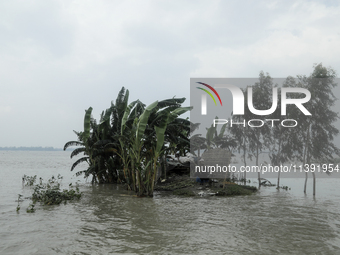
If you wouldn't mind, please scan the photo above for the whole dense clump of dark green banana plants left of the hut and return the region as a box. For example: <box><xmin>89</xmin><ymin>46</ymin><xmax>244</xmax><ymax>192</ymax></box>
<box><xmin>64</xmin><ymin>88</ymin><xmax>190</xmax><ymax>196</ymax></box>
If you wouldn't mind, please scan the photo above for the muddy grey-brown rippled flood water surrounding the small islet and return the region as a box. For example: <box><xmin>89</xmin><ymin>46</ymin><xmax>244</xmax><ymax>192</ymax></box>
<box><xmin>0</xmin><ymin>151</ymin><xmax>340</xmax><ymax>255</ymax></box>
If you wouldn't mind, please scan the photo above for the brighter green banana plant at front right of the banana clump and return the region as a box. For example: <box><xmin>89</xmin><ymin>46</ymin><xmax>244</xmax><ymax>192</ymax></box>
<box><xmin>119</xmin><ymin>100</ymin><xmax>190</xmax><ymax>196</ymax></box>
